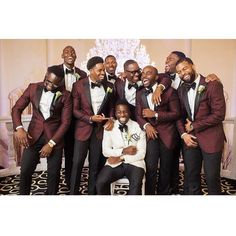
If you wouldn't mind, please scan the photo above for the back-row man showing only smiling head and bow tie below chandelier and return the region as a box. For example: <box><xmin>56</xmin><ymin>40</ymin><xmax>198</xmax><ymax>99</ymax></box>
<box><xmin>104</xmin><ymin>55</ymin><xmax>118</xmax><ymax>84</ymax></box>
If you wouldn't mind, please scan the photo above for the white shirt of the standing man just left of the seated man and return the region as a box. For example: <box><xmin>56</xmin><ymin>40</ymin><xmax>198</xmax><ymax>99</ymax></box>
<box><xmin>89</xmin><ymin>77</ymin><xmax>106</xmax><ymax>115</ymax></box>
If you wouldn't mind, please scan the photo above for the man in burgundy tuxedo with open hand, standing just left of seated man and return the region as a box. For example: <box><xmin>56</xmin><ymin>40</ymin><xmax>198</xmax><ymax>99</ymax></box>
<box><xmin>70</xmin><ymin>56</ymin><xmax>114</xmax><ymax>194</ymax></box>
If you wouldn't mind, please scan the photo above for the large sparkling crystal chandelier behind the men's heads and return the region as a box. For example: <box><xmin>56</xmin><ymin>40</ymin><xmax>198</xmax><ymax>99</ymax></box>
<box><xmin>81</xmin><ymin>39</ymin><xmax>155</xmax><ymax>72</ymax></box>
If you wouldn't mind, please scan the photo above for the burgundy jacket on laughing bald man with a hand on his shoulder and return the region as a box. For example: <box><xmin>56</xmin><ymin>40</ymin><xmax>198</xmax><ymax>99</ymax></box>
<box><xmin>136</xmin><ymin>83</ymin><xmax>180</xmax><ymax>149</ymax></box>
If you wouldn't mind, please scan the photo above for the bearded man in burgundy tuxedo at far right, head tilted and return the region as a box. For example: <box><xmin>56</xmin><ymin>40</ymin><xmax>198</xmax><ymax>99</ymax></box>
<box><xmin>176</xmin><ymin>58</ymin><xmax>226</xmax><ymax>195</ymax></box>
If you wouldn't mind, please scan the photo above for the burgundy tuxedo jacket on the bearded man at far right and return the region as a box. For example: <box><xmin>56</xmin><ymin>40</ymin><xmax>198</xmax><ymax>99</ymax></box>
<box><xmin>177</xmin><ymin>75</ymin><xmax>226</xmax><ymax>153</ymax></box>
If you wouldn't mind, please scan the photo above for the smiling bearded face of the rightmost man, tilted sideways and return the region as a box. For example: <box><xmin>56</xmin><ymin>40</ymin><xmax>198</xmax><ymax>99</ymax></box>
<box><xmin>176</xmin><ymin>61</ymin><xmax>196</xmax><ymax>84</ymax></box>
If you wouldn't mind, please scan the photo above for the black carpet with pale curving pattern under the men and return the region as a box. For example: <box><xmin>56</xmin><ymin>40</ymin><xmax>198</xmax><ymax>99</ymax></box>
<box><xmin>0</xmin><ymin>167</ymin><xmax>236</xmax><ymax>195</ymax></box>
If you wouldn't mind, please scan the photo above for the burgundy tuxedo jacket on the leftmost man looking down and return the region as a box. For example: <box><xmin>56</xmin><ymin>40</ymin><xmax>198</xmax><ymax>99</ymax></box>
<box><xmin>12</xmin><ymin>82</ymin><xmax>72</xmax><ymax>148</ymax></box>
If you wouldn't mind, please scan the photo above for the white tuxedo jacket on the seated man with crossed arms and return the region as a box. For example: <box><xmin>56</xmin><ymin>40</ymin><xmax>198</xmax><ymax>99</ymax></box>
<box><xmin>102</xmin><ymin>119</ymin><xmax>146</xmax><ymax>170</ymax></box>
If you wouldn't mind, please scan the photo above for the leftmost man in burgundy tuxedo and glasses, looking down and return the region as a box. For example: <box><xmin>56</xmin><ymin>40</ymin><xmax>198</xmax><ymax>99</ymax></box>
<box><xmin>12</xmin><ymin>66</ymin><xmax>72</xmax><ymax>195</ymax></box>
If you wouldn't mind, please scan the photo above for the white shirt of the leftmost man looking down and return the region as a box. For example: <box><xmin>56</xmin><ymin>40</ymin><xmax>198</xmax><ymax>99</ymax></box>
<box><xmin>39</xmin><ymin>90</ymin><xmax>55</xmax><ymax>120</ymax></box>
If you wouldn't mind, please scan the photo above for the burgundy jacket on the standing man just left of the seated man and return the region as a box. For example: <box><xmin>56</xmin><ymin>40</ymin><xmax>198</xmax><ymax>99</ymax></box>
<box><xmin>72</xmin><ymin>77</ymin><xmax>114</xmax><ymax>141</ymax></box>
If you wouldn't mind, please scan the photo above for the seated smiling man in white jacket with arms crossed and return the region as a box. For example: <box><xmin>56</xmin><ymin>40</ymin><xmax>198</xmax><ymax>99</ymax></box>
<box><xmin>96</xmin><ymin>101</ymin><xmax>146</xmax><ymax>195</ymax></box>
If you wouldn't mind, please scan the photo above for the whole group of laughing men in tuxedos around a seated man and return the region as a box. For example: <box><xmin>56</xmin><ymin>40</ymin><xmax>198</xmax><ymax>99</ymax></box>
<box><xmin>12</xmin><ymin>46</ymin><xmax>225</xmax><ymax>195</ymax></box>
